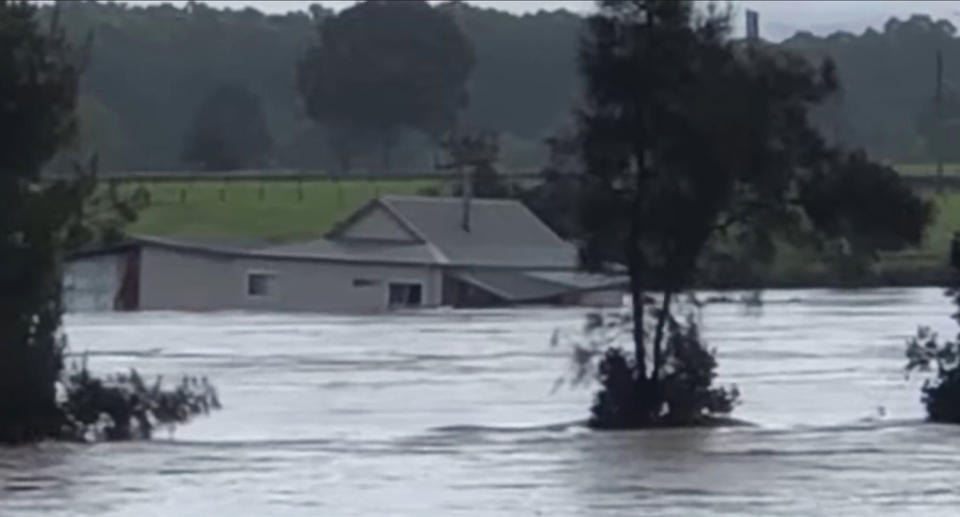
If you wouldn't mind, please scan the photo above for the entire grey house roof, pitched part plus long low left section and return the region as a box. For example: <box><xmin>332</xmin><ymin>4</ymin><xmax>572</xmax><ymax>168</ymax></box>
<box><xmin>67</xmin><ymin>196</ymin><xmax>578</xmax><ymax>272</ymax></box>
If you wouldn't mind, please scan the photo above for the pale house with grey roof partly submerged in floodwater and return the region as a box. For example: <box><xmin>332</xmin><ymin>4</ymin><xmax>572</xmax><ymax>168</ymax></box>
<box><xmin>64</xmin><ymin>196</ymin><xmax>625</xmax><ymax>312</ymax></box>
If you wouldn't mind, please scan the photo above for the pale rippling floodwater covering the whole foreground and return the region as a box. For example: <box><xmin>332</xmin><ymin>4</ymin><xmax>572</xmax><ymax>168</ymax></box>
<box><xmin>0</xmin><ymin>289</ymin><xmax>960</xmax><ymax>517</ymax></box>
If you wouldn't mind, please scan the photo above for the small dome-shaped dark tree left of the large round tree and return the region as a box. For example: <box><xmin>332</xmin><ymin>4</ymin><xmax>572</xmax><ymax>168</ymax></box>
<box><xmin>183</xmin><ymin>85</ymin><xmax>273</xmax><ymax>171</ymax></box>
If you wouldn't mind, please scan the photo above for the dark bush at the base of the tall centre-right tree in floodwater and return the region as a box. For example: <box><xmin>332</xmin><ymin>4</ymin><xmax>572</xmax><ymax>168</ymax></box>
<box><xmin>554</xmin><ymin>298</ymin><xmax>740</xmax><ymax>429</ymax></box>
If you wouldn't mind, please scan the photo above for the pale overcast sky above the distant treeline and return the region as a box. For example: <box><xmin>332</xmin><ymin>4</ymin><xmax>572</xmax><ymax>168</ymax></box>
<box><xmin>110</xmin><ymin>0</ymin><xmax>960</xmax><ymax>41</ymax></box>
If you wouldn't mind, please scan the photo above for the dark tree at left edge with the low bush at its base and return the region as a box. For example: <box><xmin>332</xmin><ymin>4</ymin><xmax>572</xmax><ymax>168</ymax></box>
<box><xmin>0</xmin><ymin>0</ymin><xmax>219</xmax><ymax>443</ymax></box>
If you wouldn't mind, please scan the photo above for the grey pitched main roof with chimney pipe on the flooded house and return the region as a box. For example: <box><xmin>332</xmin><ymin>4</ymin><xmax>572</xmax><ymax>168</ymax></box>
<box><xmin>329</xmin><ymin>196</ymin><xmax>577</xmax><ymax>268</ymax></box>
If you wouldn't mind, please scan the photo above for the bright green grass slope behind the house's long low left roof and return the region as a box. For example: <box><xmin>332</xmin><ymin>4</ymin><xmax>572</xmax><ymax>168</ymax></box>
<box><xmin>121</xmin><ymin>180</ymin><xmax>441</xmax><ymax>241</ymax></box>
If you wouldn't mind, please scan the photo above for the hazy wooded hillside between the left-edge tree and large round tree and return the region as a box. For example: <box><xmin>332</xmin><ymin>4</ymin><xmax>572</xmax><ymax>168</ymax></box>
<box><xmin>41</xmin><ymin>2</ymin><xmax>320</xmax><ymax>172</ymax></box>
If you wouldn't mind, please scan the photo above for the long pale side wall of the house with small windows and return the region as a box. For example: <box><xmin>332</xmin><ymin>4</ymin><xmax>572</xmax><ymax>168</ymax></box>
<box><xmin>139</xmin><ymin>246</ymin><xmax>442</xmax><ymax>312</ymax></box>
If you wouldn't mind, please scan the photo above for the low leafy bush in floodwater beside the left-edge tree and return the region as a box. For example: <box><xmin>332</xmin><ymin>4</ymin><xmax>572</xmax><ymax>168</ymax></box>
<box><xmin>60</xmin><ymin>358</ymin><xmax>220</xmax><ymax>441</ymax></box>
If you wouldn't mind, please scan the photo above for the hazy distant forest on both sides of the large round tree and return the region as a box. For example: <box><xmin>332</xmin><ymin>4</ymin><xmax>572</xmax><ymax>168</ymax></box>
<box><xmin>41</xmin><ymin>1</ymin><xmax>582</xmax><ymax>172</ymax></box>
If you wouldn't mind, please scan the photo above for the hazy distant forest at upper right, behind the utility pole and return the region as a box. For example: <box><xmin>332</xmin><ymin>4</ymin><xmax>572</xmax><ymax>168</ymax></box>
<box><xmin>781</xmin><ymin>14</ymin><xmax>960</xmax><ymax>162</ymax></box>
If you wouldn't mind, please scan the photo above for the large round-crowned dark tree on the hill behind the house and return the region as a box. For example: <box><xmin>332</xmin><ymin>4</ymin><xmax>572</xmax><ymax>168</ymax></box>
<box><xmin>297</xmin><ymin>0</ymin><xmax>473</xmax><ymax>173</ymax></box>
